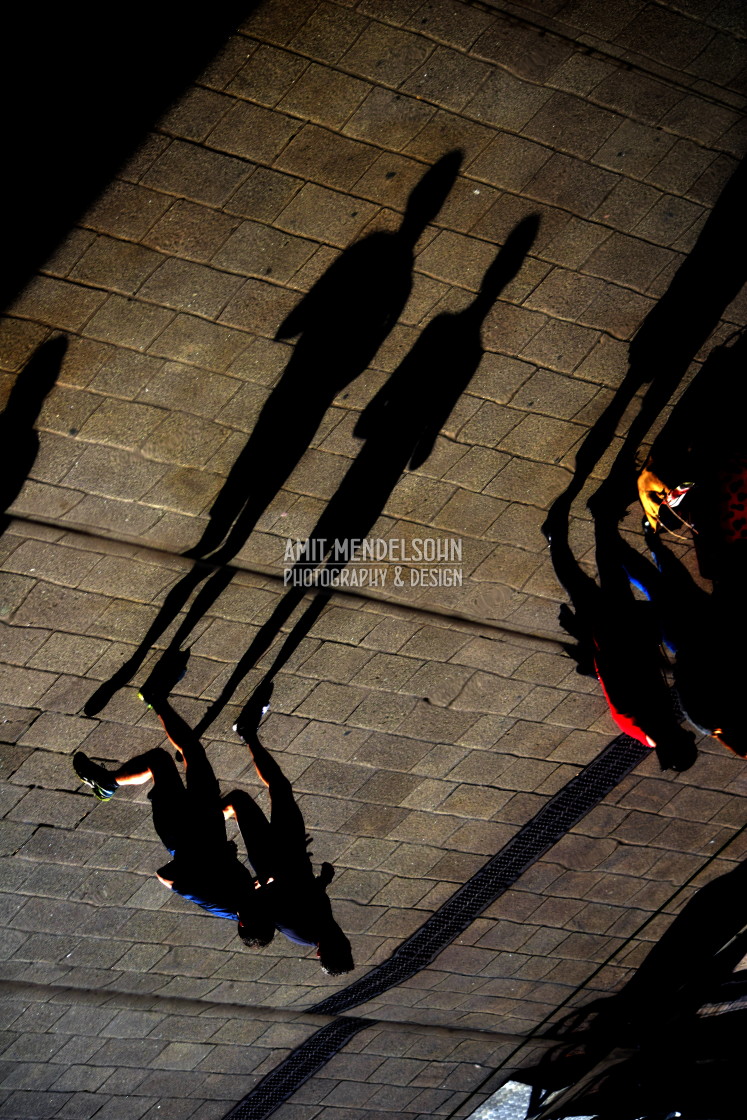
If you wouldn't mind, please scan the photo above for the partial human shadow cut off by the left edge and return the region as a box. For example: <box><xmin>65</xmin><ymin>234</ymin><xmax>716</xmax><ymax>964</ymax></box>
<box><xmin>0</xmin><ymin>335</ymin><xmax>67</xmax><ymax>534</ymax></box>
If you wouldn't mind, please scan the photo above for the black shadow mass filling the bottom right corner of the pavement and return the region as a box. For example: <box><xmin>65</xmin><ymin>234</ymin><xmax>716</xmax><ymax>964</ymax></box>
<box><xmin>515</xmin><ymin>862</ymin><xmax>747</xmax><ymax>1120</ymax></box>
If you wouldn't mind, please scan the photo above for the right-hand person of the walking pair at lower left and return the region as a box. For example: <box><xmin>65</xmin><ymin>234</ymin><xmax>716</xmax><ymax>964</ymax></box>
<box><xmin>223</xmin><ymin>685</ymin><xmax>355</xmax><ymax>976</ymax></box>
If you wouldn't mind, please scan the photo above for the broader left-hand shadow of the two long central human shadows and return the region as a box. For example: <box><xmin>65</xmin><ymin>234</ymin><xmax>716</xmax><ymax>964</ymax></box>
<box><xmin>84</xmin><ymin>151</ymin><xmax>461</xmax><ymax>716</ymax></box>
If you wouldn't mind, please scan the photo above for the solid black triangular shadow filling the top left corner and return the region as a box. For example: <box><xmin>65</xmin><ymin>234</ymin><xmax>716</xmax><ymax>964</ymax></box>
<box><xmin>0</xmin><ymin>0</ymin><xmax>256</xmax><ymax>307</ymax></box>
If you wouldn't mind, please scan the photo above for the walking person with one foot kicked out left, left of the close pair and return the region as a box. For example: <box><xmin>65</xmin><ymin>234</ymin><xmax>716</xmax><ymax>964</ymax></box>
<box><xmin>73</xmin><ymin>654</ymin><xmax>274</xmax><ymax>946</ymax></box>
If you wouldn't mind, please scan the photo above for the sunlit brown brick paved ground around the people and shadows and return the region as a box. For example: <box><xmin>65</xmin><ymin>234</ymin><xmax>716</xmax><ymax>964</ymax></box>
<box><xmin>0</xmin><ymin>0</ymin><xmax>747</xmax><ymax>1120</ymax></box>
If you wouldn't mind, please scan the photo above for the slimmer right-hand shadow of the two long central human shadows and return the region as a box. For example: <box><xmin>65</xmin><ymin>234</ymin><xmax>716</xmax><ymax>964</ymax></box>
<box><xmin>199</xmin><ymin>215</ymin><xmax>539</xmax><ymax>730</ymax></box>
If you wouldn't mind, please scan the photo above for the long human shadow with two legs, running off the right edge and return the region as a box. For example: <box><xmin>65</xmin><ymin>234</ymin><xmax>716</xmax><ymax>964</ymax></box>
<box><xmin>550</xmin><ymin>151</ymin><xmax>747</xmax><ymax>526</ymax></box>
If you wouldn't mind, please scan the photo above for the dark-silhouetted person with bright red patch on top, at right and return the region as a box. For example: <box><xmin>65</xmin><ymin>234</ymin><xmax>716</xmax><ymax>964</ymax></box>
<box><xmin>543</xmin><ymin>497</ymin><xmax>698</xmax><ymax>772</ymax></box>
